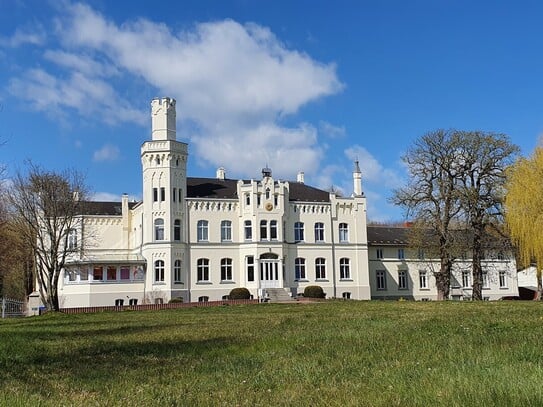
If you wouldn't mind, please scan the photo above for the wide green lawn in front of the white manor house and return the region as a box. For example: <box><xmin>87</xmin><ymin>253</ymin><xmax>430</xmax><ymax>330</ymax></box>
<box><xmin>0</xmin><ymin>301</ymin><xmax>543</xmax><ymax>406</ymax></box>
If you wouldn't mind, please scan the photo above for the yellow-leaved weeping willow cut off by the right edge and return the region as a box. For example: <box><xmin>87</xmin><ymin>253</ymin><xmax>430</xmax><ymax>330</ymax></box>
<box><xmin>505</xmin><ymin>147</ymin><xmax>543</xmax><ymax>299</ymax></box>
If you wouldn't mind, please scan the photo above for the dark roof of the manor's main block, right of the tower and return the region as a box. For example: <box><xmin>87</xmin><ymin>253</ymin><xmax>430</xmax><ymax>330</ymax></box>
<box><xmin>187</xmin><ymin>177</ymin><xmax>330</xmax><ymax>202</ymax></box>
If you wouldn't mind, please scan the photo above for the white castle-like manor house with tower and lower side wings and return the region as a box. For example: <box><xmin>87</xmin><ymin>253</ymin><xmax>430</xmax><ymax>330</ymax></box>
<box><xmin>50</xmin><ymin>98</ymin><xmax>518</xmax><ymax>308</ymax></box>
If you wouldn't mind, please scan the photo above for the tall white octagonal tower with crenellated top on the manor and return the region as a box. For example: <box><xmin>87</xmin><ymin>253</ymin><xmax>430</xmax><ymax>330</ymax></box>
<box><xmin>141</xmin><ymin>97</ymin><xmax>188</xmax><ymax>301</ymax></box>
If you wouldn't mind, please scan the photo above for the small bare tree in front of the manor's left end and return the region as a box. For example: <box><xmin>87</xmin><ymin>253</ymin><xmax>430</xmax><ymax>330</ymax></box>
<box><xmin>8</xmin><ymin>163</ymin><xmax>88</xmax><ymax>311</ymax></box>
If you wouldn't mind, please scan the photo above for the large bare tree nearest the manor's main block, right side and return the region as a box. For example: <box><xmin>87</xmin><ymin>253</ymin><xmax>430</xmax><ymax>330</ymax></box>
<box><xmin>390</xmin><ymin>130</ymin><xmax>461</xmax><ymax>299</ymax></box>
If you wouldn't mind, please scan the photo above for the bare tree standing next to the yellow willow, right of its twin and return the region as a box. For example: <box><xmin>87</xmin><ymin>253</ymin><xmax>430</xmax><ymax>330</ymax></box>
<box><xmin>457</xmin><ymin>131</ymin><xmax>520</xmax><ymax>300</ymax></box>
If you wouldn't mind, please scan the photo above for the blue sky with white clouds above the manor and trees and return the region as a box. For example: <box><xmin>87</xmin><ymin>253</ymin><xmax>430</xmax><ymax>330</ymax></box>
<box><xmin>0</xmin><ymin>0</ymin><xmax>543</xmax><ymax>221</ymax></box>
